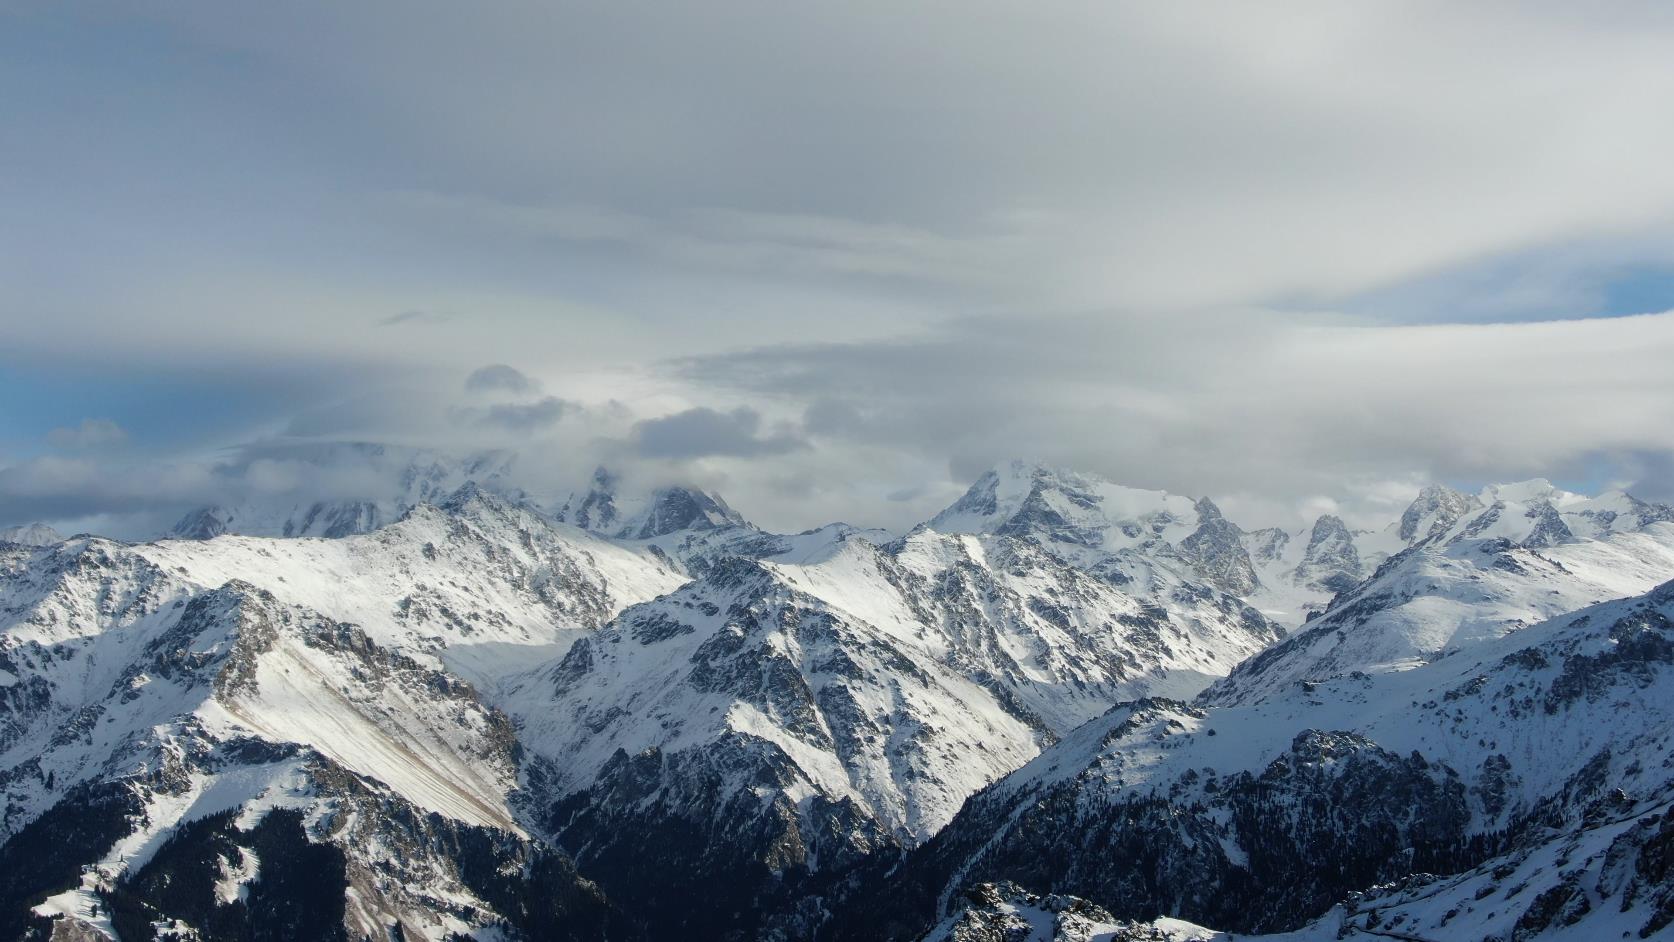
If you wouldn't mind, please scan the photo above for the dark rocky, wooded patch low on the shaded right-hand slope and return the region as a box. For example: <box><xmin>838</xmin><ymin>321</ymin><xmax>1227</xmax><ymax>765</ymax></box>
<box><xmin>830</xmin><ymin>701</ymin><xmax>1470</xmax><ymax>935</ymax></box>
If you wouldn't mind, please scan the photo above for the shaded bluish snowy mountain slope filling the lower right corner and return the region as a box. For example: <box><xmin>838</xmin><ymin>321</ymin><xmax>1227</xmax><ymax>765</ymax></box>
<box><xmin>839</xmin><ymin>582</ymin><xmax>1674</xmax><ymax>939</ymax></box>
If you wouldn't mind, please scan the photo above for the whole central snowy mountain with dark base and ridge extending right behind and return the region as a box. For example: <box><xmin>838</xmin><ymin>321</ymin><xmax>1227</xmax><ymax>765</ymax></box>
<box><xmin>504</xmin><ymin>530</ymin><xmax>1279</xmax><ymax>934</ymax></box>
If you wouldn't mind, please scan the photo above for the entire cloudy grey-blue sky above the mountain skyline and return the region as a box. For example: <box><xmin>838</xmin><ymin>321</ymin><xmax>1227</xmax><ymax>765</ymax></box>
<box><xmin>0</xmin><ymin>0</ymin><xmax>1674</xmax><ymax>537</ymax></box>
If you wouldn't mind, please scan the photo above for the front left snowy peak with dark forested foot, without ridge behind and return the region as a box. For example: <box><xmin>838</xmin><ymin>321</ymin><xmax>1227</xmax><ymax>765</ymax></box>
<box><xmin>0</xmin><ymin>582</ymin><xmax>619</xmax><ymax>939</ymax></box>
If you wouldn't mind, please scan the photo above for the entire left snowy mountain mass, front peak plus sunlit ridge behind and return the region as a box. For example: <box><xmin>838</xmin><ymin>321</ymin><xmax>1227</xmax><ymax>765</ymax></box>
<box><xmin>0</xmin><ymin>485</ymin><xmax>685</xmax><ymax>939</ymax></box>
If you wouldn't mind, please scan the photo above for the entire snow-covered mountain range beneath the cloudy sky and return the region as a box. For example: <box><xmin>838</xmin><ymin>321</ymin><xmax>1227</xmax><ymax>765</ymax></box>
<box><xmin>0</xmin><ymin>445</ymin><xmax>1674</xmax><ymax>940</ymax></box>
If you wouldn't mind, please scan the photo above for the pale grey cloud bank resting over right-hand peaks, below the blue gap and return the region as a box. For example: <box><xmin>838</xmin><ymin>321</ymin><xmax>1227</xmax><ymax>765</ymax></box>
<box><xmin>671</xmin><ymin>311</ymin><xmax>1674</xmax><ymax>520</ymax></box>
